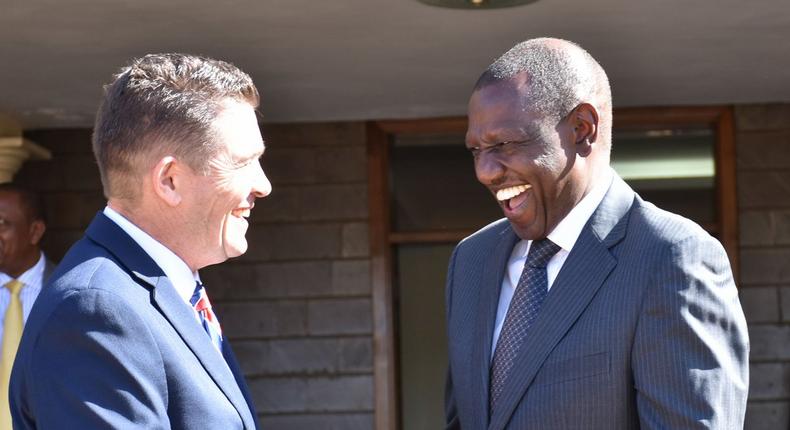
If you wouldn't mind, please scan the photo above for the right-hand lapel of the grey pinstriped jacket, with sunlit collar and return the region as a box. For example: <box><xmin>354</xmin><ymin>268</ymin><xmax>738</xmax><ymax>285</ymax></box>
<box><xmin>488</xmin><ymin>176</ymin><xmax>634</xmax><ymax>430</ymax></box>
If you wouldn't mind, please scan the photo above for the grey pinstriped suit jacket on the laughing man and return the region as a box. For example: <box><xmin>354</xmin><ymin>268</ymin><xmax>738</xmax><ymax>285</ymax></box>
<box><xmin>446</xmin><ymin>177</ymin><xmax>749</xmax><ymax>430</ymax></box>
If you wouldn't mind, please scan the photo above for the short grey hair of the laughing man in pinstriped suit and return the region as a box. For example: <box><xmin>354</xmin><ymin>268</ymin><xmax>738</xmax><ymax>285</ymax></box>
<box><xmin>475</xmin><ymin>38</ymin><xmax>612</xmax><ymax>125</ymax></box>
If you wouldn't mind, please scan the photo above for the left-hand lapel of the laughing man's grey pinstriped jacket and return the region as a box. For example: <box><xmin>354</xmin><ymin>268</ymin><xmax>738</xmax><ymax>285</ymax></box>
<box><xmin>472</xmin><ymin>224</ymin><xmax>519</xmax><ymax>428</ymax></box>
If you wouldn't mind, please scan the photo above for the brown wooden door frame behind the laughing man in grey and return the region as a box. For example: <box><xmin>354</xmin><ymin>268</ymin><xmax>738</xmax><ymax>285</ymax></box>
<box><xmin>366</xmin><ymin>106</ymin><xmax>738</xmax><ymax>430</ymax></box>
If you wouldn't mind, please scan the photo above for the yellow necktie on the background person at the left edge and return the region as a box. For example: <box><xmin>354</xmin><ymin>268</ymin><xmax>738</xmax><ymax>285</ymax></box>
<box><xmin>0</xmin><ymin>279</ymin><xmax>23</xmax><ymax>429</ymax></box>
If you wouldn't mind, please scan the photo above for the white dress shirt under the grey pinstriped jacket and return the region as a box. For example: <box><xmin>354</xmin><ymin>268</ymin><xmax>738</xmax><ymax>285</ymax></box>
<box><xmin>491</xmin><ymin>169</ymin><xmax>613</xmax><ymax>357</ymax></box>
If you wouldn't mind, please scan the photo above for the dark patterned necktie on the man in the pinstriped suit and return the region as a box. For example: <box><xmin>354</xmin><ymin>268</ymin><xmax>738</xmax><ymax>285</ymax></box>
<box><xmin>489</xmin><ymin>239</ymin><xmax>560</xmax><ymax>416</ymax></box>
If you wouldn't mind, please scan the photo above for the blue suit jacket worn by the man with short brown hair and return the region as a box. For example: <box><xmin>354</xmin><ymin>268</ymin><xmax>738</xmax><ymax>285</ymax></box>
<box><xmin>10</xmin><ymin>213</ymin><xmax>257</xmax><ymax>429</ymax></box>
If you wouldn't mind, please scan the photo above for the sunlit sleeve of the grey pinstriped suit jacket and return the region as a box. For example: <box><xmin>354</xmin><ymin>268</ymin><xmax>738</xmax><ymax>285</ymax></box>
<box><xmin>631</xmin><ymin>233</ymin><xmax>749</xmax><ymax>429</ymax></box>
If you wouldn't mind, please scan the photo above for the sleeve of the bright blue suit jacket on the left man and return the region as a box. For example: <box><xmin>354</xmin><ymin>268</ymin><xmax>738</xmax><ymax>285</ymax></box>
<box><xmin>11</xmin><ymin>289</ymin><xmax>170</xmax><ymax>429</ymax></box>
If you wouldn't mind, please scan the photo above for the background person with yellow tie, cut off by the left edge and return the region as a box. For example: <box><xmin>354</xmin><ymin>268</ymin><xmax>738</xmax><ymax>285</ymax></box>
<box><xmin>0</xmin><ymin>183</ymin><xmax>55</xmax><ymax>429</ymax></box>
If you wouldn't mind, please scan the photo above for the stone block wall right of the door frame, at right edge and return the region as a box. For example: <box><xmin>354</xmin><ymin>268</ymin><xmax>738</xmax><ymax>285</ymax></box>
<box><xmin>735</xmin><ymin>104</ymin><xmax>790</xmax><ymax>430</ymax></box>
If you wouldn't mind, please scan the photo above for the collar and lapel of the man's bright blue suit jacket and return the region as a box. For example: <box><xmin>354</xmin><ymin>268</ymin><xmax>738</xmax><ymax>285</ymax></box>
<box><xmin>86</xmin><ymin>213</ymin><xmax>256</xmax><ymax>429</ymax></box>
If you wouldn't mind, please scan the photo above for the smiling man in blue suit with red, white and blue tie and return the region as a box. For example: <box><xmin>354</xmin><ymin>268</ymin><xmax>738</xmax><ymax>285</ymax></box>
<box><xmin>11</xmin><ymin>54</ymin><xmax>271</xmax><ymax>429</ymax></box>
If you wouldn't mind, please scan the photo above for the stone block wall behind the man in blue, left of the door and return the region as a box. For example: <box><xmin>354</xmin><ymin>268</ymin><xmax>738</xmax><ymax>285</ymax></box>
<box><xmin>16</xmin><ymin>123</ymin><xmax>373</xmax><ymax>430</ymax></box>
